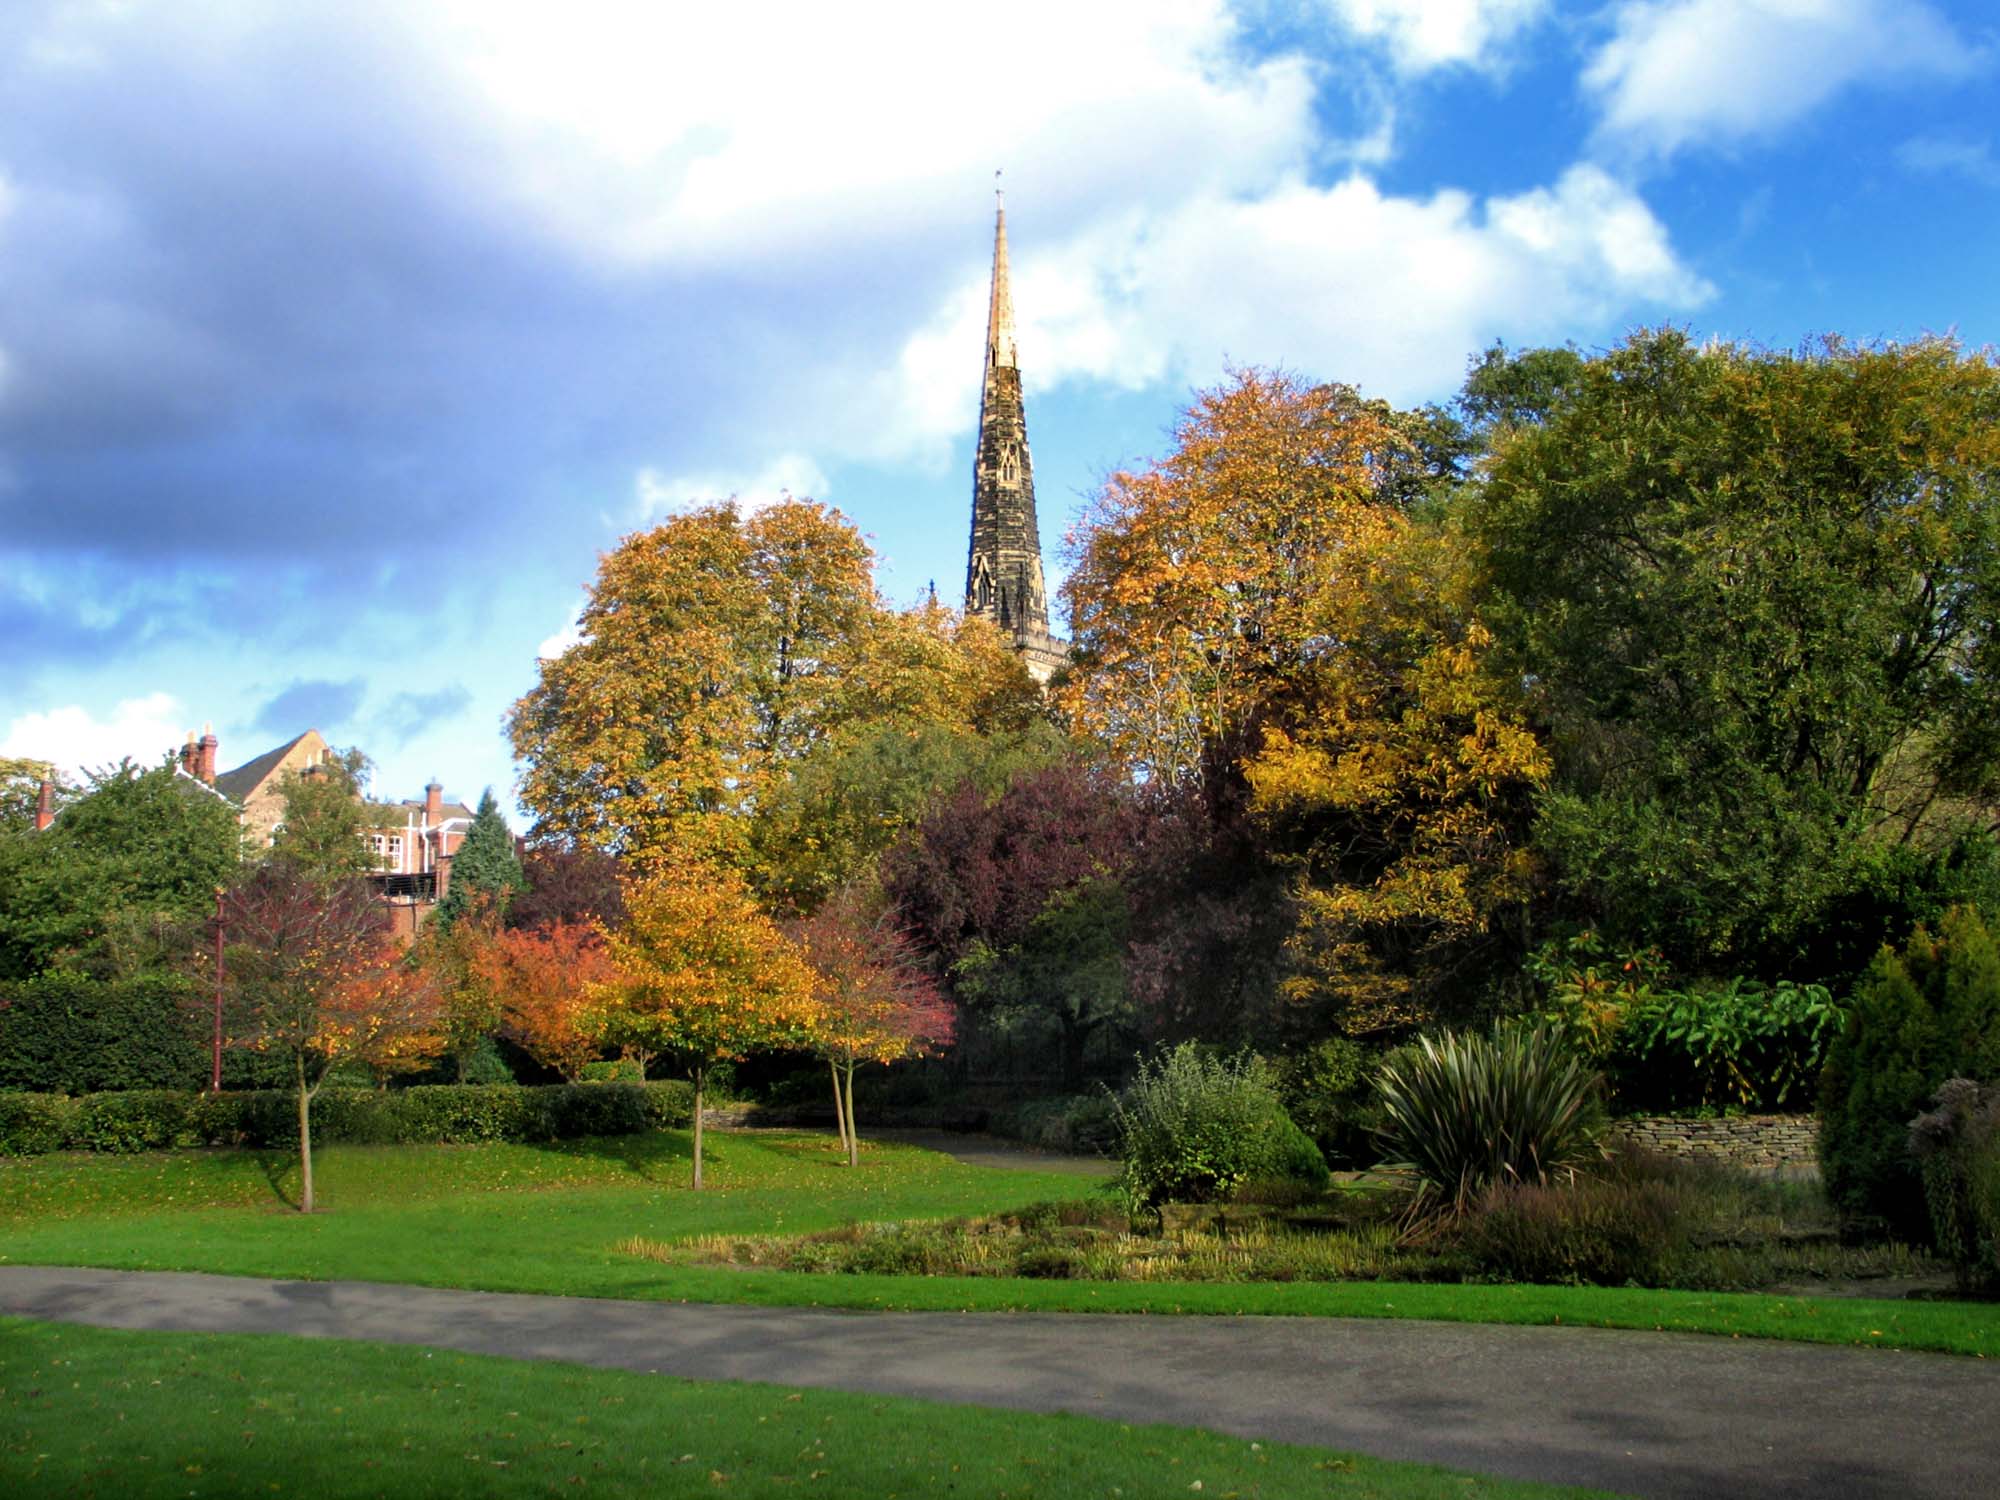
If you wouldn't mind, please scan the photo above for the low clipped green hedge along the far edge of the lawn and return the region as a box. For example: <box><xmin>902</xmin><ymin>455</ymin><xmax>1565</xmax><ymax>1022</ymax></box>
<box><xmin>0</xmin><ymin>1082</ymin><xmax>694</xmax><ymax>1156</ymax></box>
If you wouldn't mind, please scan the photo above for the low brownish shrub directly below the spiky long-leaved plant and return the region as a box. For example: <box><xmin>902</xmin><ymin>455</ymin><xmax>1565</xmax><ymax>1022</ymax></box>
<box><xmin>1456</xmin><ymin>1176</ymin><xmax>1692</xmax><ymax>1286</ymax></box>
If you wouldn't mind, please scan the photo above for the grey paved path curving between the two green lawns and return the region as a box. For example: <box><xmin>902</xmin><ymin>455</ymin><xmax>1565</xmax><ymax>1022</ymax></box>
<box><xmin>0</xmin><ymin>1266</ymin><xmax>2000</xmax><ymax>1500</ymax></box>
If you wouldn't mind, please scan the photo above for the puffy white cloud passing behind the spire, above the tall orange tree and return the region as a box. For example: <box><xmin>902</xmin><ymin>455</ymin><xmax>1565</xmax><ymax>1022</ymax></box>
<box><xmin>858</xmin><ymin>166</ymin><xmax>1714</xmax><ymax>446</ymax></box>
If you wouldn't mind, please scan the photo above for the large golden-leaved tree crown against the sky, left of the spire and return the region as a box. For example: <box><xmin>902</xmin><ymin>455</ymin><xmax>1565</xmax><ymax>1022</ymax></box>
<box><xmin>508</xmin><ymin>500</ymin><xmax>874</xmax><ymax>860</ymax></box>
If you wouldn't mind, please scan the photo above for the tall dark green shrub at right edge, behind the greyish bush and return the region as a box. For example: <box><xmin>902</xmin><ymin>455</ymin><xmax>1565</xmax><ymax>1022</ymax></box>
<box><xmin>1820</xmin><ymin>906</ymin><xmax>2000</xmax><ymax>1244</ymax></box>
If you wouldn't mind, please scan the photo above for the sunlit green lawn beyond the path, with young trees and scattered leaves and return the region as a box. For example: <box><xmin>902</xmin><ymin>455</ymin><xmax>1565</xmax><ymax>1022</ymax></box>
<box><xmin>0</xmin><ymin>1132</ymin><xmax>2000</xmax><ymax>1358</ymax></box>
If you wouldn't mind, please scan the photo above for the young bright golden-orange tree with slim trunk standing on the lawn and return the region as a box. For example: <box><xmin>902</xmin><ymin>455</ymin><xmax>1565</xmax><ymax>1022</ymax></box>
<box><xmin>592</xmin><ymin>854</ymin><xmax>820</xmax><ymax>1188</ymax></box>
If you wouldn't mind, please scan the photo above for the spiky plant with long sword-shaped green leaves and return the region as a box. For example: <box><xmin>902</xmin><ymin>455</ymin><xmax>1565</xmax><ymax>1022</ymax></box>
<box><xmin>1376</xmin><ymin>1024</ymin><xmax>1604</xmax><ymax>1212</ymax></box>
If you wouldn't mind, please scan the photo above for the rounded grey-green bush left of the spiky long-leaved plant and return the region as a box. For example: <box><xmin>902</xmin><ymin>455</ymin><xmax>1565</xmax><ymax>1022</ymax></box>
<box><xmin>1116</xmin><ymin>1042</ymin><xmax>1326</xmax><ymax>1208</ymax></box>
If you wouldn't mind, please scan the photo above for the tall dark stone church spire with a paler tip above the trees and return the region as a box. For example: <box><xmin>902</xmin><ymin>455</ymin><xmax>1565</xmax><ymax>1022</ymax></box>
<box><xmin>966</xmin><ymin>191</ymin><xmax>1066</xmax><ymax>682</ymax></box>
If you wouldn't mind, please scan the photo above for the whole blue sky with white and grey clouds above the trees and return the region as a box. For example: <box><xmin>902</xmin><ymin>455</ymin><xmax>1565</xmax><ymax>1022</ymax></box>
<box><xmin>0</xmin><ymin>0</ymin><xmax>2000</xmax><ymax>828</ymax></box>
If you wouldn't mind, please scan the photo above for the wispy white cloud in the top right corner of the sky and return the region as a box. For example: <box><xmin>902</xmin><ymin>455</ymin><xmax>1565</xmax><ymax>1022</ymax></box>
<box><xmin>1584</xmin><ymin>0</ymin><xmax>1978</xmax><ymax>154</ymax></box>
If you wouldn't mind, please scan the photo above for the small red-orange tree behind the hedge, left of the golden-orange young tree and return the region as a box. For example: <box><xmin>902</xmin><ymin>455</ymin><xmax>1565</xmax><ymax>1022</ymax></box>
<box><xmin>472</xmin><ymin>920</ymin><xmax>616</xmax><ymax>1084</ymax></box>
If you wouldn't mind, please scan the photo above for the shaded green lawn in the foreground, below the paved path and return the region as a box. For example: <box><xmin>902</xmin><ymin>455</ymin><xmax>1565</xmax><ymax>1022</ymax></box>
<box><xmin>0</xmin><ymin>1320</ymin><xmax>1616</xmax><ymax>1500</ymax></box>
